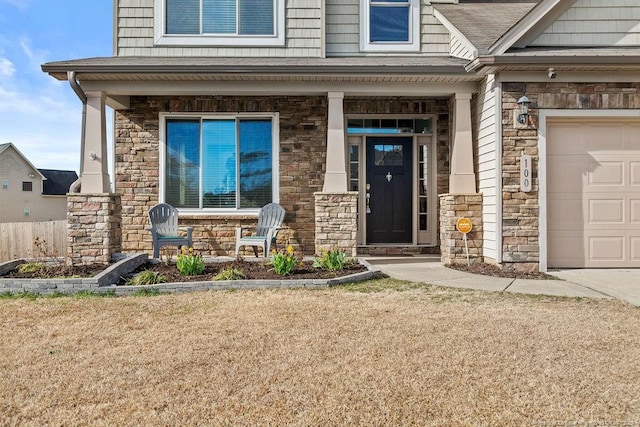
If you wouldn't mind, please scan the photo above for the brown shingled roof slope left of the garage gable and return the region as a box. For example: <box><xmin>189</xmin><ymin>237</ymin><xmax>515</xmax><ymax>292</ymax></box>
<box><xmin>433</xmin><ymin>0</ymin><xmax>538</xmax><ymax>53</ymax></box>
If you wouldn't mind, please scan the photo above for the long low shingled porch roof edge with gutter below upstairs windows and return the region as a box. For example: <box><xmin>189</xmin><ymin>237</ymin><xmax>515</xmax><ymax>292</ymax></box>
<box><xmin>42</xmin><ymin>56</ymin><xmax>467</xmax><ymax>80</ymax></box>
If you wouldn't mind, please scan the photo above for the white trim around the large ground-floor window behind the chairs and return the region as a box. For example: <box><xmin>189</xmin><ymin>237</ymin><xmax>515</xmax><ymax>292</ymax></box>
<box><xmin>158</xmin><ymin>112</ymin><xmax>280</xmax><ymax>216</ymax></box>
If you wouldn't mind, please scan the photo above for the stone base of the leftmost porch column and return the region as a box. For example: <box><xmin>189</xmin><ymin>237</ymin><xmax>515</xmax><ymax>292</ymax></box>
<box><xmin>67</xmin><ymin>193</ymin><xmax>122</xmax><ymax>265</ymax></box>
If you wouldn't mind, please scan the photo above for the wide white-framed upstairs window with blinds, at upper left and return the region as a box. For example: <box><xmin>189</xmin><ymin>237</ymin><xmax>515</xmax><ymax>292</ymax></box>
<box><xmin>155</xmin><ymin>0</ymin><xmax>285</xmax><ymax>46</ymax></box>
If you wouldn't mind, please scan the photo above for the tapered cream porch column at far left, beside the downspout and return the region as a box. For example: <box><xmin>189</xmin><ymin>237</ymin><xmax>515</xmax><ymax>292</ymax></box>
<box><xmin>81</xmin><ymin>91</ymin><xmax>109</xmax><ymax>194</ymax></box>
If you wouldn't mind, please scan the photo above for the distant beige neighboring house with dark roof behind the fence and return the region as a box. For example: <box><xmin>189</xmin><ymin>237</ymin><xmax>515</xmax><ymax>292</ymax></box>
<box><xmin>0</xmin><ymin>143</ymin><xmax>78</xmax><ymax>222</ymax></box>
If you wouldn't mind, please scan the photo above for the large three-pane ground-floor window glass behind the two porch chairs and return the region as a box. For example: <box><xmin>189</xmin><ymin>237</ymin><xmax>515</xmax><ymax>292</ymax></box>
<box><xmin>164</xmin><ymin>117</ymin><xmax>277</xmax><ymax>210</ymax></box>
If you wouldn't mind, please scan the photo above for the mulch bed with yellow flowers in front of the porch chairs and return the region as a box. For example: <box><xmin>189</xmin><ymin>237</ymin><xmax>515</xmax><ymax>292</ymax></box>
<box><xmin>120</xmin><ymin>260</ymin><xmax>366</xmax><ymax>284</ymax></box>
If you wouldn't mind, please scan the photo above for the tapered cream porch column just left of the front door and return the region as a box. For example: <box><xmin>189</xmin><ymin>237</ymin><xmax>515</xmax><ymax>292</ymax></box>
<box><xmin>322</xmin><ymin>92</ymin><xmax>347</xmax><ymax>193</ymax></box>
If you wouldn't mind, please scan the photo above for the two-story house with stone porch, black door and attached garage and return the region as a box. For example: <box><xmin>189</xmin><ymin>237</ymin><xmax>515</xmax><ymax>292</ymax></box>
<box><xmin>43</xmin><ymin>0</ymin><xmax>640</xmax><ymax>270</ymax></box>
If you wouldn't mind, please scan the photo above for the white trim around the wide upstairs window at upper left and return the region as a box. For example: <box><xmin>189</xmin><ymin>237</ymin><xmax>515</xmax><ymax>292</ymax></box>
<box><xmin>153</xmin><ymin>0</ymin><xmax>285</xmax><ymax>47</ymax></box>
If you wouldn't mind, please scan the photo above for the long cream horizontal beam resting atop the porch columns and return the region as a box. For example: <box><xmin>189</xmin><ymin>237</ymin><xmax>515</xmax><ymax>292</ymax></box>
<box><xmin>82</xmin><ymin>81</ymin><xmax>478</xmax><ymax>98</ymax></box>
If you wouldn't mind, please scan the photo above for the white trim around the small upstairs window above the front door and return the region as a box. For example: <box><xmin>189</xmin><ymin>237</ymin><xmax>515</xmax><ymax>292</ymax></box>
<box><xmin>360</xmin><ymin>0</ymin><xmax>420</xmax><ymax>52</ymax></box>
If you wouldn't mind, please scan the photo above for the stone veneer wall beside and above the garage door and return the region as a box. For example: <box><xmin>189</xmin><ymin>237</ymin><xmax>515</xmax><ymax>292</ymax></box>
<box><xmin>502</xmin><ymin>82</ymin><xmax>640</xmax><ymax>270</ymax></box>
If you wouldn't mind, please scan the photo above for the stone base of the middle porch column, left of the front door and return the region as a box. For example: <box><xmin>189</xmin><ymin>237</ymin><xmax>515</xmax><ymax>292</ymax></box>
<box><xmin>313</xmin><ymin>191</ymin><xmax>358</xmax><ymax>256</ymax></box>
